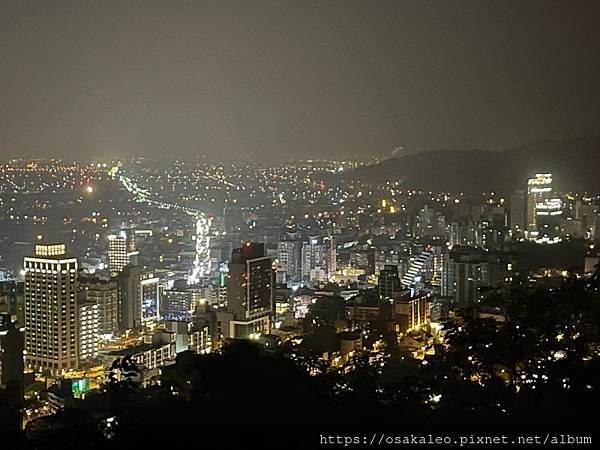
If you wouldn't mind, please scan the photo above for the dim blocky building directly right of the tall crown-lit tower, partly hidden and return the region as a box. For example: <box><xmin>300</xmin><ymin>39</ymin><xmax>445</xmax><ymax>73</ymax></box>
<box><xmin>79</xmin><ymin>278</ymin><xmax>119</xmax><ymax>335</ymax></box>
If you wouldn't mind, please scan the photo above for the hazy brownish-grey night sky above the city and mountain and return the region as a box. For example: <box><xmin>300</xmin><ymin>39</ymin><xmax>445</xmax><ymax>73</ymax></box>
<box><xmin>0</xmin><ymin>0</ymin><xmax>600</xmax><ymax>159</ymax></box>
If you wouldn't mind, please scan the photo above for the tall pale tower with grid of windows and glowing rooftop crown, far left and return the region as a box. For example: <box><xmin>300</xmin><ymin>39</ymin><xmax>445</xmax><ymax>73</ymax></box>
<box><xmin>24</xmin><ymin>244</ymin><xmax>78</xmax><ymax>374</ymax></box>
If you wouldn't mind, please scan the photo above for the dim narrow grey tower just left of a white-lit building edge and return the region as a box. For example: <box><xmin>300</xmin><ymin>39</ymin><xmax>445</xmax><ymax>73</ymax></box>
<box><xmin>116</xmin><ymin>266</ymin><xmax>142</xmax><ymax>331</ymax></box>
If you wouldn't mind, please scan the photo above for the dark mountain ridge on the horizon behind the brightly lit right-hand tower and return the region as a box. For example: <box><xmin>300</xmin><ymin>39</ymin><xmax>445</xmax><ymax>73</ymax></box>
<box><xmin>330</xmin><ymin>137</ymin><xmax>600</xmax><ymax>193</ymax></box>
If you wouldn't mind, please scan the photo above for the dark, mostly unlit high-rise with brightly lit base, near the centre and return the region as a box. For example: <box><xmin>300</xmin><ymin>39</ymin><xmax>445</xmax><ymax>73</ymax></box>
<box><xmin>222</xmin><ymin>242</ymin><xmax>273</xmax><ymax>338</ymax></box>
